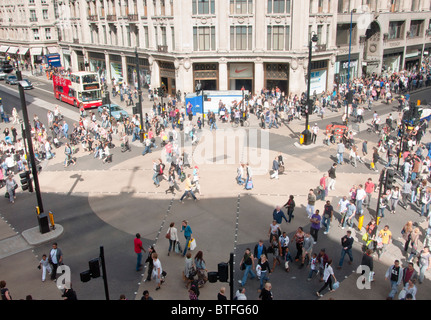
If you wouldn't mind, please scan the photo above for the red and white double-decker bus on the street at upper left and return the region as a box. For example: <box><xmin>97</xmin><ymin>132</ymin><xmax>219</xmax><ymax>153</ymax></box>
<box><xmin>52</xmin><ymin>71</ymin><xmax>102</xmax><ymax>109</ymax></box>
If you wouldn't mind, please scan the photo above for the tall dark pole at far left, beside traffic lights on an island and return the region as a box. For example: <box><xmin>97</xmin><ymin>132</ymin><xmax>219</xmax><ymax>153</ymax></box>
<box><xmin>16</xmin><ymin>70</ymin><xmax>44</xmax><ymax>213</ymax></box>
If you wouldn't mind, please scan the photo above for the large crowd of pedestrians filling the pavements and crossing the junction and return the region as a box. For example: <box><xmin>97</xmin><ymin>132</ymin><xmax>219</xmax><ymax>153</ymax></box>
<box><xmin>0</xmin><ymin>56</ymin><xmax>431</xmax><ymax>300</ymax></box>
